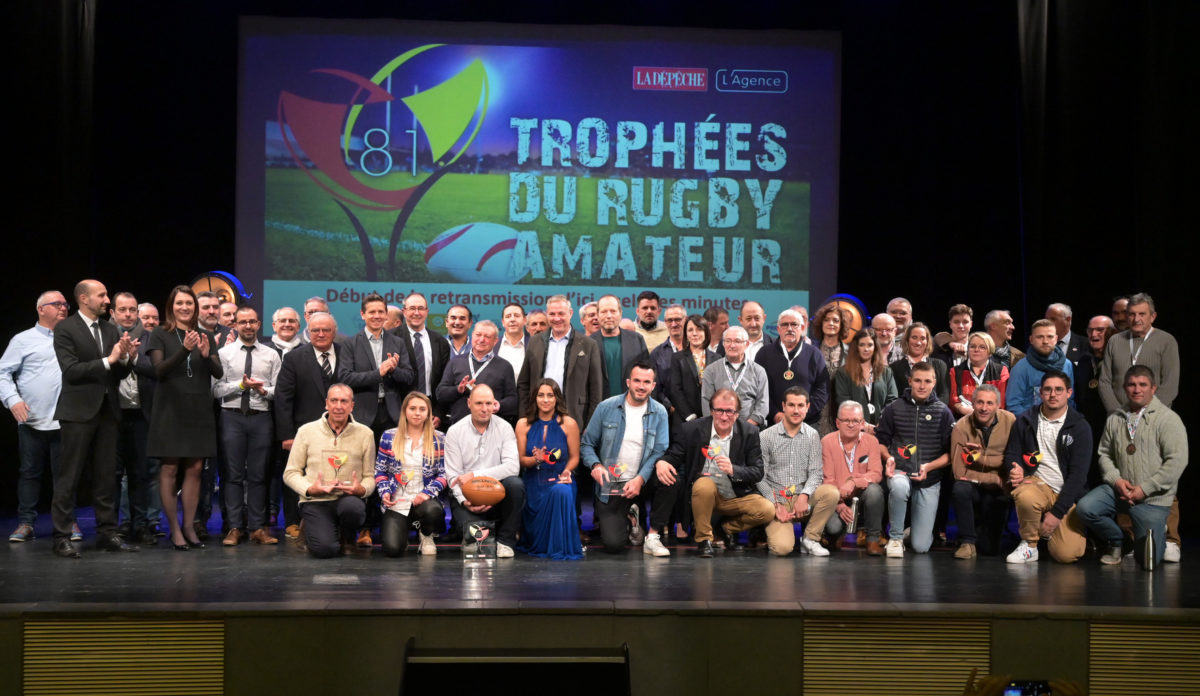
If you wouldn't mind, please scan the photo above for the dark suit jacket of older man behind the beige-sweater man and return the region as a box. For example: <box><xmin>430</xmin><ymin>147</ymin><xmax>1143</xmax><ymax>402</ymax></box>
<box><xmin>275</xmin><ymin>343</ymin><xmax>352</xmax><ymax>440</ymax></box>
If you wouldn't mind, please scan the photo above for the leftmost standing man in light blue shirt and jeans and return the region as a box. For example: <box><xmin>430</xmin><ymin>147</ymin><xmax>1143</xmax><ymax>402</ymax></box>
<box><xmin>0</xmin><ymin>290</ymin><xmax>69</xmax><ymax>541</ymax></box>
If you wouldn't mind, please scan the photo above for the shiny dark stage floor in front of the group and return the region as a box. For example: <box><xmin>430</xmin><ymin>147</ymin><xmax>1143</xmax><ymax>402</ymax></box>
<box><xmin>0</xmin><ymin>515</ymin><xmax>1200</xmax><ymax>620</ymax></box>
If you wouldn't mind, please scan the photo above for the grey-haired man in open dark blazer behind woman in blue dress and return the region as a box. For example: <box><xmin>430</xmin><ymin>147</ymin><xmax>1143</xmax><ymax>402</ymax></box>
<box><xmin>517</xmin><ymin>295</ymin><xmax>604</xmax><ymax>428</ymax></box>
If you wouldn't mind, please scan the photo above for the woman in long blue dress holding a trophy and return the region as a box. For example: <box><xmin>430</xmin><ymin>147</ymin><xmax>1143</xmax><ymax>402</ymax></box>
<box><xmin>516</xmin><ymin>379</ymin><xmax>583</xmax><ymax>560</ymax></box>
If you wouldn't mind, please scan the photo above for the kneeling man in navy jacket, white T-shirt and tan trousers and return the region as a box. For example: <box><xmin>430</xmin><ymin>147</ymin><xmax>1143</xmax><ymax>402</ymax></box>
<box><xmin>1004</xmin><ymin>370</ymin><xmax>1092</xmax><ymax>563</ymax></box>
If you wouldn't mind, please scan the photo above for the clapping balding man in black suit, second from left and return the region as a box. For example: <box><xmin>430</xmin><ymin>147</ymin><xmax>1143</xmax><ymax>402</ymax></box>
<box><xmin>50</xmin><ymin>280</ymin><xmax>138</xmax><ymax>558</ymax></box>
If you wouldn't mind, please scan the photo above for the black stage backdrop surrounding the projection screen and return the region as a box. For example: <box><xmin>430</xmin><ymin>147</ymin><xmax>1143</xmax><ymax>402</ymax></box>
<box><xmin>0</xmin><ymin>0</ymin><xmax>1200</xmax><ymax>528</ymax></box>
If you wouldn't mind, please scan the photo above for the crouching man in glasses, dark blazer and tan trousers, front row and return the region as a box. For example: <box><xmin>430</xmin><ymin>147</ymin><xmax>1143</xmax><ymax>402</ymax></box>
<box><xmin>655</xmin><ymin>389</ymin><xmax>775</xmax><ymax>558</ymax></box>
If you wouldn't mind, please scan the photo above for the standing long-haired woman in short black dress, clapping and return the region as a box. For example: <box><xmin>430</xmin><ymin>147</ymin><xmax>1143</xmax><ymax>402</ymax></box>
<box><xmin>146</xmin><ymin>286</ymin><xmax>223</xmax><ymax>551</ymax></box>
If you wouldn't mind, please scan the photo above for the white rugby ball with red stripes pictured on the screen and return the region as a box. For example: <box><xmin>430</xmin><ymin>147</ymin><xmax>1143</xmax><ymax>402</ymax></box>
<box><xmin>425</xmin><ymin>222</ymin><xmax>524</xmax><ymax>284</ymax></box>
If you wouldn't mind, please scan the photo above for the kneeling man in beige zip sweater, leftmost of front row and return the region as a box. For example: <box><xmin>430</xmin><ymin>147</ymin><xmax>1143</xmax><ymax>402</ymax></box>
<box><xmin>283</xmin><ymin>384</ymin><xmax>374</xmax><ymax>558</ymax></box>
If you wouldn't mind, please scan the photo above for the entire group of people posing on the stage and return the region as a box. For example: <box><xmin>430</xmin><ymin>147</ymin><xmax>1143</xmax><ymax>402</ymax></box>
<box><xmin>0</xmin><ymin>281</ymin><xmax>1187</xmax><ymax>564</ymax></box>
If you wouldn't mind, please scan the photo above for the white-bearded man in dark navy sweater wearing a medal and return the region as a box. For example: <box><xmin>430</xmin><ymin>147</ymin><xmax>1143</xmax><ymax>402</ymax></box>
<box><xmin>755</xmin><ymin>308</ymin><xmax>829</xmax><ymax>427</ymax></box>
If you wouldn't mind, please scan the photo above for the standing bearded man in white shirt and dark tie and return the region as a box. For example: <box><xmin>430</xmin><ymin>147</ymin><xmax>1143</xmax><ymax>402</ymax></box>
<box><xmin>212</xmin><ymin>307</ymin><xmax>283</xmax><ymax>546</ymax></box>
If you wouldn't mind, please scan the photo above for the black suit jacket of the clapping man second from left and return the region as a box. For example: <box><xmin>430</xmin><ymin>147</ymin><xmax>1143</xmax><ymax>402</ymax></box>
<box><xmin>54</xmin><ymin>312</ymin><xmax>130</xmax><ymax>422</ymax></box>
